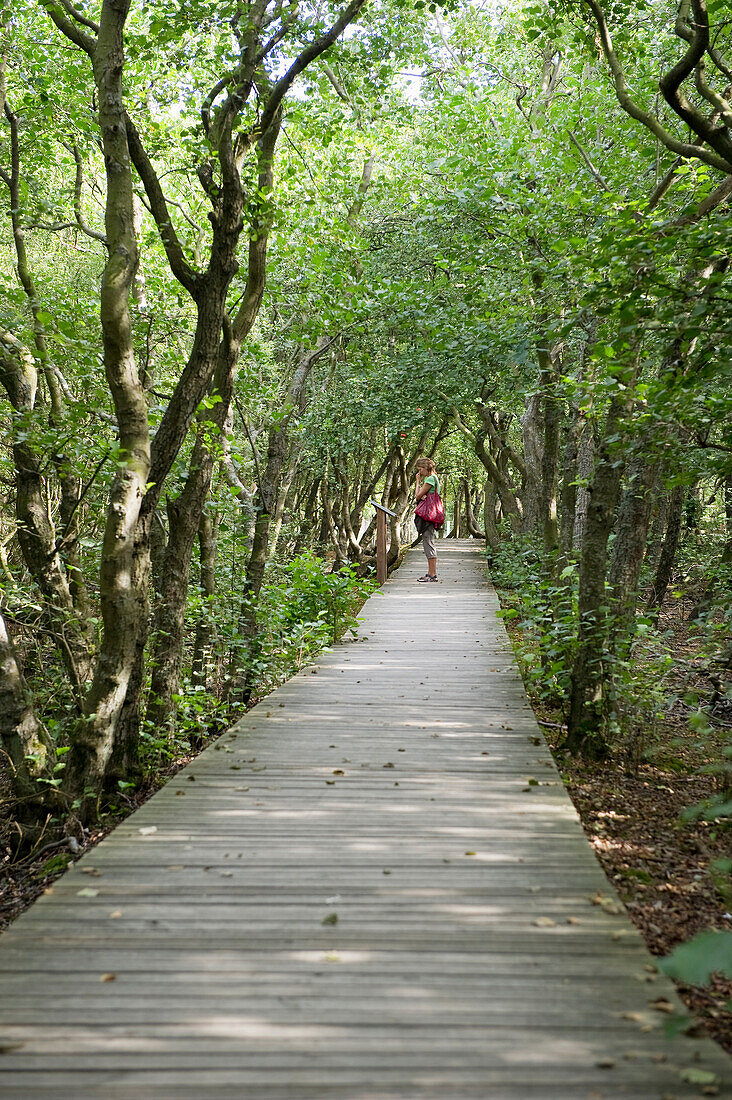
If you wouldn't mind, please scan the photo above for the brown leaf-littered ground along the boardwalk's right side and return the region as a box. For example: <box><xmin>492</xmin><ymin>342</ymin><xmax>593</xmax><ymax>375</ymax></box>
<box><xmin>499</xmin><ymin>603</ymin><xmax>732</xmax><ymax>1054</ymax></box>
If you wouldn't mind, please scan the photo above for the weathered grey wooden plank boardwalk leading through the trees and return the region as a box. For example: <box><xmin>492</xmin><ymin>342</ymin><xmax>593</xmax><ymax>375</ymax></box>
<box><xmin>0</xmin><ymin>542</ymin><xmax>730</xmax><ymax>1100</ymax></box>
